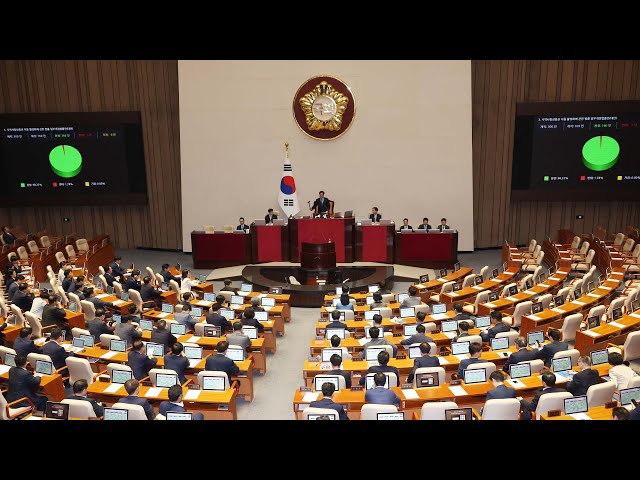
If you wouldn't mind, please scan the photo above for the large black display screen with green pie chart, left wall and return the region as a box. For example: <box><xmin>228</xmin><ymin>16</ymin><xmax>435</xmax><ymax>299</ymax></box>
<box><xmin>0</xmin><ymin>112</ymin><xmax>147</xmax><ymax>205</ymax></box>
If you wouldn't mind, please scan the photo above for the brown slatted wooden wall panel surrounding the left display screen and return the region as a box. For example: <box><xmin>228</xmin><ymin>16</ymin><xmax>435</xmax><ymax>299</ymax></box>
<box><xmin>0</xmin><ymin>60</ymin><xmax>182</xmax><ymax>249</ymax></box>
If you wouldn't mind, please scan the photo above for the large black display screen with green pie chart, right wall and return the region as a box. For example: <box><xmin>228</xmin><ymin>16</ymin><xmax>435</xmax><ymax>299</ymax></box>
<box><xmin>511</xmin><ymin>102</ymin><xmax>640</xmax><ymax>201</ymax></box>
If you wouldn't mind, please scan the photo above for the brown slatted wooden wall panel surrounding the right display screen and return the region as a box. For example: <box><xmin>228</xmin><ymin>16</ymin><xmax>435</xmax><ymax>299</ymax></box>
<box><xmin>471</xmin><ymin>60</ymin><xmax>640</xmax><ymax>248</ymax></box>
